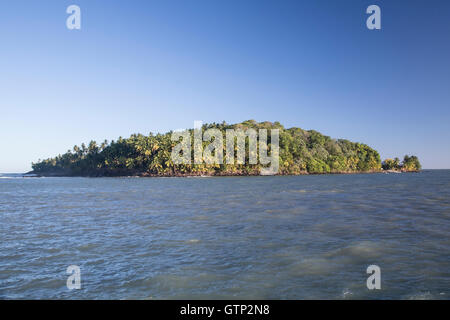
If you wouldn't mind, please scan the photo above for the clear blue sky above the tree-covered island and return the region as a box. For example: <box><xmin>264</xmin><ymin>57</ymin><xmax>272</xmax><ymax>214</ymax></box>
<box><xmin>0</xmin><ymin>0</ymin><xmax>450</xmax><ymax>172</ymax></box>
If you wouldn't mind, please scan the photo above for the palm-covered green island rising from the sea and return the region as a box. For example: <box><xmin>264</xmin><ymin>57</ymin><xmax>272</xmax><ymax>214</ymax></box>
<box><xmin>30</xmin><ymin>120</ymin><xmax>421</xmax><ymax>177</ymax></box>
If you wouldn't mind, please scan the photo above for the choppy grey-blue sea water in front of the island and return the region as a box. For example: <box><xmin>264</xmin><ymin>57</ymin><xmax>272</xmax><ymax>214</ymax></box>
<box><xmin>0</xmin><ymin>170</ymin><xmax>450</xmax><ymax>299</ymax></box>
